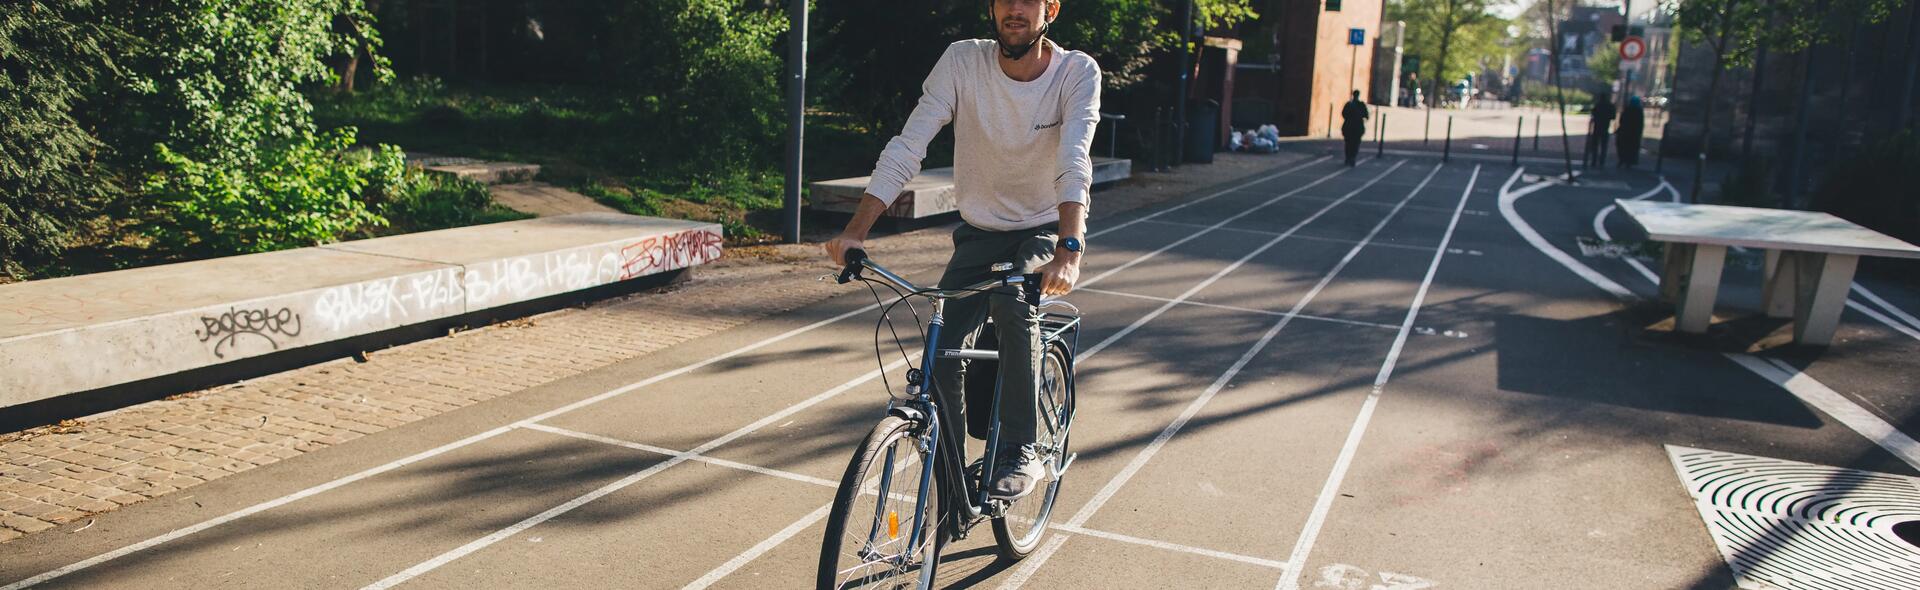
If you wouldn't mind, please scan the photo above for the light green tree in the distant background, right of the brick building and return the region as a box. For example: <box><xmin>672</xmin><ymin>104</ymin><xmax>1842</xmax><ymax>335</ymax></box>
<box><xmin>1386</xmin><ymin>0</ymin><xmax>1507</xmax><ymax>104</ymax></box>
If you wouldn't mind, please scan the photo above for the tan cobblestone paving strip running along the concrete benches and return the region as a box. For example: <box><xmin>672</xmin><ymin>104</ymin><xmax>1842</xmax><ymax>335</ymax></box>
<box><xmin>0</xmin><ymin>154</ymin><xmax>1308</xmax><ymax>542</ymax></box>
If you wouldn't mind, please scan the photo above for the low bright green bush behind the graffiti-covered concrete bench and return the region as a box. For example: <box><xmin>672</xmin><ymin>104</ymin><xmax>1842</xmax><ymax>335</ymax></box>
<box><xmin>142</xmin><ymin>129</ymin><xmax>405</xmax><ymax>254</ymax></box>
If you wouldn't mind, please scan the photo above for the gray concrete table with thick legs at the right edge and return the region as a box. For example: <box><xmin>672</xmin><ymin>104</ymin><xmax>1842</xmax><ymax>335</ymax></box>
<box><xmin>1615</xmin><ymin>200</ymin><xmax>1920</xmax><ymax>346</ymax></box>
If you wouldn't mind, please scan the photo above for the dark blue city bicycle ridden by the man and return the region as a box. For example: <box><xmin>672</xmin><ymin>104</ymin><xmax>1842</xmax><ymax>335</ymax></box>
<box><xmin>818</xmin><ymin>250</ymin><xmax>1081</xmax><ymax>588</ymax></box>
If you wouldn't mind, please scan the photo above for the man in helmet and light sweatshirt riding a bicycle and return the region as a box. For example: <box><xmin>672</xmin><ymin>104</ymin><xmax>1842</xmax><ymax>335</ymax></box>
<box><xmin>826</xmin><ymin>0</ymin><xmax>1100</xmax><ymax>502</ymax></box>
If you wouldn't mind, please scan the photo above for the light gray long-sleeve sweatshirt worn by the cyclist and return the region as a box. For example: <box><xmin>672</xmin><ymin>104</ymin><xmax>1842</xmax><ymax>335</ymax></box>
<box><xmin>866</xmin><ymin>38</ymin><xmax>1100</xmax><ymax>231</ymax></box>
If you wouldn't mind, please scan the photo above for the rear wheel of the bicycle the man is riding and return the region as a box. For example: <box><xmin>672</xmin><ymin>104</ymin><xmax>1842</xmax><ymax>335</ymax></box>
<box><xmin>993</xmin><ymin>342</ymin><xmax>1073</xmax><ymax>559</ymax></box>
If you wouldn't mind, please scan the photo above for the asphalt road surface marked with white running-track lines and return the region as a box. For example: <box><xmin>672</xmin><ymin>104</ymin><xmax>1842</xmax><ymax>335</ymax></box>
<box><xmin>0</xmin><ymin>158</ymin><xmax>1920</xmax><ymax>588</ymax></box>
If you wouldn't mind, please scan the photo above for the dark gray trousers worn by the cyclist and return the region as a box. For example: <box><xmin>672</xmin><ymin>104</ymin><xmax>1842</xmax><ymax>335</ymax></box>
<box><xmin>933</xmin><ymin>223</ymin><xmax>1060</xmax><ymax>448</ymax></box>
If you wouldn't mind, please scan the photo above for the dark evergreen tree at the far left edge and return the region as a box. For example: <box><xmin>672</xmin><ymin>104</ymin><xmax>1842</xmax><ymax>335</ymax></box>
<box><xmin>0</xmin><ymin>0</ymin><xmax>127</xmax><ymax>279</ymax></box>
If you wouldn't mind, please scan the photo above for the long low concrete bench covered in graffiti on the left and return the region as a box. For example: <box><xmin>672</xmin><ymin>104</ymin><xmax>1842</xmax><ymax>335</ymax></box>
<box><xmin>0</xmin><ymin>213</ymin><xmax>722</xmax><ymax>407</ymax></box>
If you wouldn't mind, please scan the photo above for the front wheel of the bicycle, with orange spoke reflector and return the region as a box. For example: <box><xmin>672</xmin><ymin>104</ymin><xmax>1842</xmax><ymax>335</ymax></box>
<box><xmin>818</xmin><ymin>415</ymin><xmax>939</xmax><ymax>590</ymax></box>
